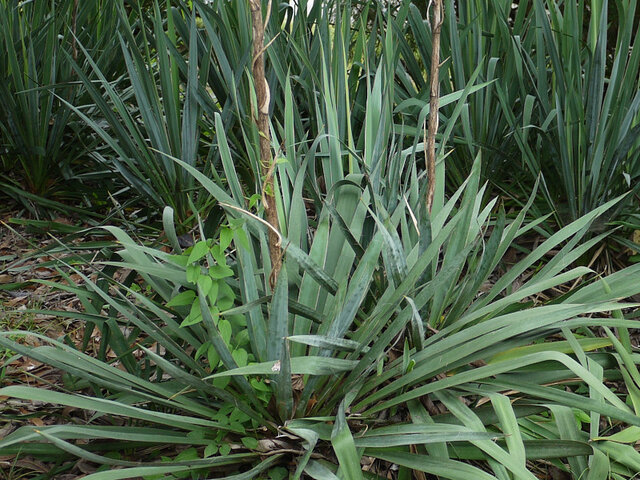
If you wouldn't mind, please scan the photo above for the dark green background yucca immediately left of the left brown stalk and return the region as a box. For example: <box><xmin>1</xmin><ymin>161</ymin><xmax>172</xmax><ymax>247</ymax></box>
<box><xmin>63</xmin><ymin>0</ymin><xmax>296</xmax><ymax>229</ymax></box>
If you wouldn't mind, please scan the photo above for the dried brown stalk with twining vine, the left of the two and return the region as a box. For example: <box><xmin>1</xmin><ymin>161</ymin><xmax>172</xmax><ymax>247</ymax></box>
<box><xmin>249</xmin><ymin>0</ymin><xmax>282</xmax><ymax>287</ymax></box>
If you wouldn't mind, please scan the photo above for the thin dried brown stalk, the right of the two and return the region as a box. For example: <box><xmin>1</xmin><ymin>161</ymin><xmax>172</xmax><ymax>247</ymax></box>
<box><xmin>424</xmin><ymin>0</ymin><xmax>444</xmax><ymax>213</ymax></box>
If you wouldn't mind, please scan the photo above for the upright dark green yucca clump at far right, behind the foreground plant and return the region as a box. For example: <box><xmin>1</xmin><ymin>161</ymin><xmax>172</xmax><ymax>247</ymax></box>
<box><xmin>503</xmin><ymin>0</ymin><xmax>640</xmax><ymax>228</ymax></box>
